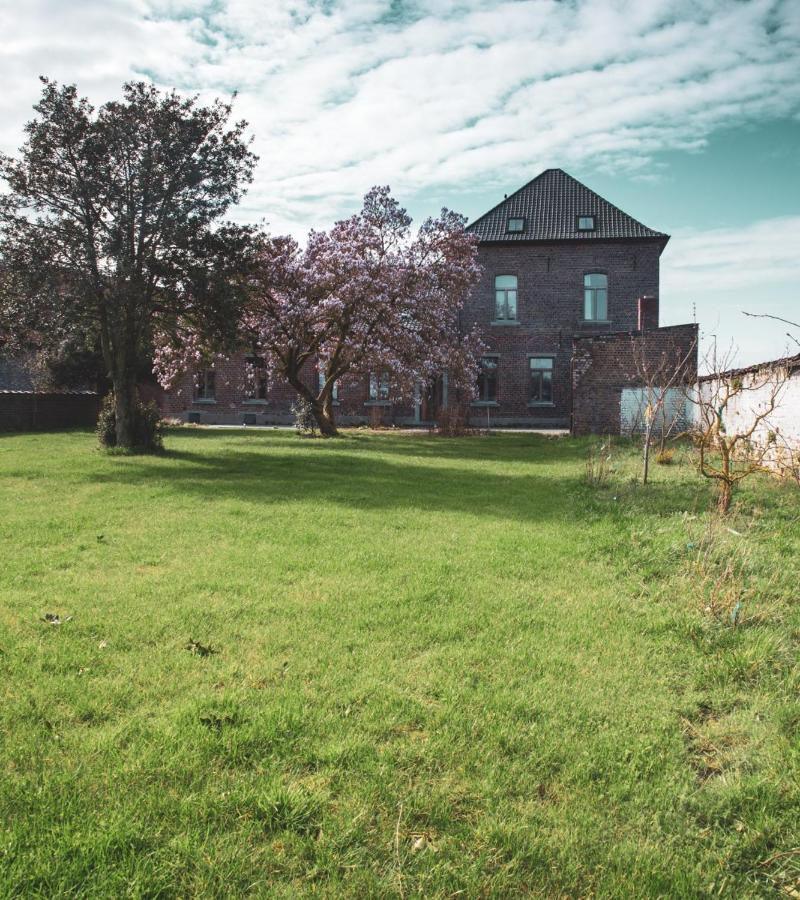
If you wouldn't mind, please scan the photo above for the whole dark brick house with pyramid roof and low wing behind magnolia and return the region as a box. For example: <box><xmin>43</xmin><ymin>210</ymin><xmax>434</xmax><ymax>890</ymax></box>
<box><xmin>165</xmin><ymin>169</ymin><xmax>697</xmax><ymax>433</ymax></box>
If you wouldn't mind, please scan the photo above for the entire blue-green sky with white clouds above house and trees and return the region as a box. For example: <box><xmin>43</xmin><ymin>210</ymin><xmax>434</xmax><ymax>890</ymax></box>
<box><xmin>0</xmin><ymin>0</ymin><xmax>800</xmax><ymax>365</ymax></box>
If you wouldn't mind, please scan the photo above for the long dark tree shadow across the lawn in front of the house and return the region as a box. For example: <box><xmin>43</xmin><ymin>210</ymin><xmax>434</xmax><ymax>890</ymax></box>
<box><xmin>79</xmin><ymin>430</ymin><xmax>708</xmax><ymax>522</ymax></box>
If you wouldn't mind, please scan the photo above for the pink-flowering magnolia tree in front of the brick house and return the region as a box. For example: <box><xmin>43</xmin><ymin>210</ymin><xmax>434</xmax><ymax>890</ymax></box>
<box><xmin>156</xmin><ymin>187</ymin><xmax>481</xmax><ymax>436</ymax></box>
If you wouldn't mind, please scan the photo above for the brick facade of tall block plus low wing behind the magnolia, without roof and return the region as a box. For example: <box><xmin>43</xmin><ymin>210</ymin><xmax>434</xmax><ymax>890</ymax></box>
<box><xmin>162</xmin><ymin>232</ymin><xmax>680</xmax><ymax>427</ymax></box>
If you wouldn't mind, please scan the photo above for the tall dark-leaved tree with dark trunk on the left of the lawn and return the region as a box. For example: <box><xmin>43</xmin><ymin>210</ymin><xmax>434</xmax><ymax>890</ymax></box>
<box><xmin>0</xmin><ymin>78</ymin><xmax>256</xmax><ymax>446</ymax></box>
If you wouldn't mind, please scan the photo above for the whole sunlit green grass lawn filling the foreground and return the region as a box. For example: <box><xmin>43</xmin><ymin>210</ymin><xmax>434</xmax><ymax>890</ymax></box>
<box><xmin>0</xmin><ymin>429</ymin><xmax>800</xmax><ymax>897</ymax></box>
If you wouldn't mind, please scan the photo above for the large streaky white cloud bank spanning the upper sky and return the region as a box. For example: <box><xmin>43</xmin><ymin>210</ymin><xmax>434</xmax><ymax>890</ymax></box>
<box><xmin>0</xmin><ymin>0</ymin><xmax>800</xmax><ymax>234</ymax></box>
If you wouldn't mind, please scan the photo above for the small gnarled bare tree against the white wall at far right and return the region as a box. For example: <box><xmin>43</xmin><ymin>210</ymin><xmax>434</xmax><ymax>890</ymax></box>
<box><xmin>692</xmin><ymin>347</ymin><xmax>788</xmax><ymax>514</ymax></box>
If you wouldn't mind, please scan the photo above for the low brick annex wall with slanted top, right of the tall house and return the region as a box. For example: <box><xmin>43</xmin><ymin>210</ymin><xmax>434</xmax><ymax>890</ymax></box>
<box><xmin>572</xmin><ymin>324</ymin><xmax>698</xmax><ymax>434</ymax></box>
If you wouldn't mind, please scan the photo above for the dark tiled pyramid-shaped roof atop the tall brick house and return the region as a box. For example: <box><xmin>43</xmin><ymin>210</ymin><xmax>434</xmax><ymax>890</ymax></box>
<box><xmin>467</xmin><ymin>169</ymin><xmax>669</xmax><ymax>244</ymax></box>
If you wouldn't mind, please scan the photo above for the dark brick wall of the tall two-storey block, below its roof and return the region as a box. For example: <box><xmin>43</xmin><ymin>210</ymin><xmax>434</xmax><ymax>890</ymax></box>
<box><xmin>462</xmin><ymin>240</ymin><xmax>662</xmax><ymax>427</ymax></box>
